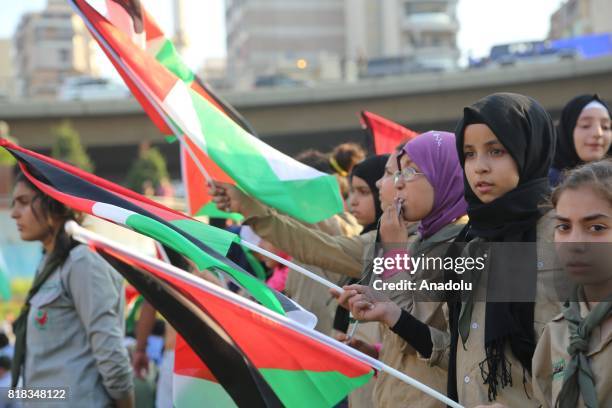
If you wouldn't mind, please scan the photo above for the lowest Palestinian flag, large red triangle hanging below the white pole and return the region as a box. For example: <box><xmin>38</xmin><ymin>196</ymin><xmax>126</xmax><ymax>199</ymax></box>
<box><xmin>77</xmin><ymin>234</ymin><xmax>373</xmax><ymax>408</ymax></box>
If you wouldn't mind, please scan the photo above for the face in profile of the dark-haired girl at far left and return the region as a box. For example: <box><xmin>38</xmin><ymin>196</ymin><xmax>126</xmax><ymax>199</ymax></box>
<box><xmin>11</xmin><ymin>183</ymin><xmax>51</xmax><ymax>241</ymax></box>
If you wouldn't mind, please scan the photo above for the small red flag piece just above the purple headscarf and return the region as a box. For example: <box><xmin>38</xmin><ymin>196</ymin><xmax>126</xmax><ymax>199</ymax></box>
<box><xmin>361</xmin><ymin>111</ymin><xmax>418</xmax><ymax>154</ymax></box>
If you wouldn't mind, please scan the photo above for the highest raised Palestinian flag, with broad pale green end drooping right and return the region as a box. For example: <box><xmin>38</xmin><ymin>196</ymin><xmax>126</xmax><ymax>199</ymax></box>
<box><xmin>70</xmin><ymin>0</ymin><xmax>343</xmax><ymax>223</ymax></box>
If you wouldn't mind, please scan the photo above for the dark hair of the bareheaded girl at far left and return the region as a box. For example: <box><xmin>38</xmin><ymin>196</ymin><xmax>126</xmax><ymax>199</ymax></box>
<box><xmin>15</xmin><ymin>172</ymin><xmax>82</xmax><ymax>260</ymax></box>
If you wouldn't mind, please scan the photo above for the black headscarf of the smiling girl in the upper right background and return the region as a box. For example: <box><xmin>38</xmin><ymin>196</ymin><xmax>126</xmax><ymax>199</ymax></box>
<box><xmin>553</xmin><ymin>94</ymin><xmax>612</xmax><ymax>171</ymax></box>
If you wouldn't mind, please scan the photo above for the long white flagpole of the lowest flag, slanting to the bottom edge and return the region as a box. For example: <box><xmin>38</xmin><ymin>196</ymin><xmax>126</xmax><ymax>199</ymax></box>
<box><xmin>65</xmin><ymin>221</ymin><xmax>463</xmax><ymax>408</ymax></box>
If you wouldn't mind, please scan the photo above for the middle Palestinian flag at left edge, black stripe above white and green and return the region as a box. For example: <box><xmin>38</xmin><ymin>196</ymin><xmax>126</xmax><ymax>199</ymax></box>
<box><xmin>0</xmin><ymin>139</ymin><xmax>316</xmax><ymax>324</ymax></box>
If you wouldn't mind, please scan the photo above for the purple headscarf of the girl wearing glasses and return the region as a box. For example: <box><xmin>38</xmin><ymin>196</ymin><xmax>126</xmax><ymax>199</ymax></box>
<box><xmin>403</xmin><ymin>130</ymin><xmax>467</xmax><ymax>238</ymax></box>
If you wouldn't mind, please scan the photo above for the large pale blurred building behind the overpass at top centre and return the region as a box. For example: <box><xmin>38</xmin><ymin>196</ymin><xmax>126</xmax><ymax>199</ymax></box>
<box><xmin>226</xmin><ymin>0</ymin><xmax>459</xmax><ymax>87</ymax></box>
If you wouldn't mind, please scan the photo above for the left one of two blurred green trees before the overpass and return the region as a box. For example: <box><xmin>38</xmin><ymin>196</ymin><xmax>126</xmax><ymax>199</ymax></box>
<box><xmin>51</xmin><ymin>120</ymin><xmax>94</xmax><ymax>172</ymax></box>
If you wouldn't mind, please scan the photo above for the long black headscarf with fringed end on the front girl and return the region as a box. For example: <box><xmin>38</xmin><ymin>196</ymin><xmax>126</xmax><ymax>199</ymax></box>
<box><xmin>454</xmin><ymin>93</ymin><xmax>555</xmax><ymax>400</ymax></box>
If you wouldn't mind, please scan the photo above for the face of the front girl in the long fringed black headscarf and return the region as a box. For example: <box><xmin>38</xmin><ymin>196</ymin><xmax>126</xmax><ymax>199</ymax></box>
<box><xmin>463</xmin><ymin>123</ymin><xmax>519</xmax><ymax>204</ymax></box>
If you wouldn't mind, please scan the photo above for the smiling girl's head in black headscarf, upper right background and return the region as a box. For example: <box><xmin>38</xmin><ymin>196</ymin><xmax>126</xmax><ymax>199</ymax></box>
<box><xmin>549</xmin><ymin>94</ymin><xmax>612</xmax><ymax>187</ymax></box>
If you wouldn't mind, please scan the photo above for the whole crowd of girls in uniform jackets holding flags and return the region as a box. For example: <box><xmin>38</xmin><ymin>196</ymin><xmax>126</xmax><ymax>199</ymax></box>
<box><xmin>0</xmin><ymin>93</ymin><xmax>612</xmax><ymax>407</ymax></box>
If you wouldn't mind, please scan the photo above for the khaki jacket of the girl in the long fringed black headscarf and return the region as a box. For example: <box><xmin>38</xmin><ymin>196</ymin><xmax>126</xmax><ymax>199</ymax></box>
<box><xmin>457</xmin><ymin>213</ymin><xmax>561</xmax><ymax>407</ymax></box>
